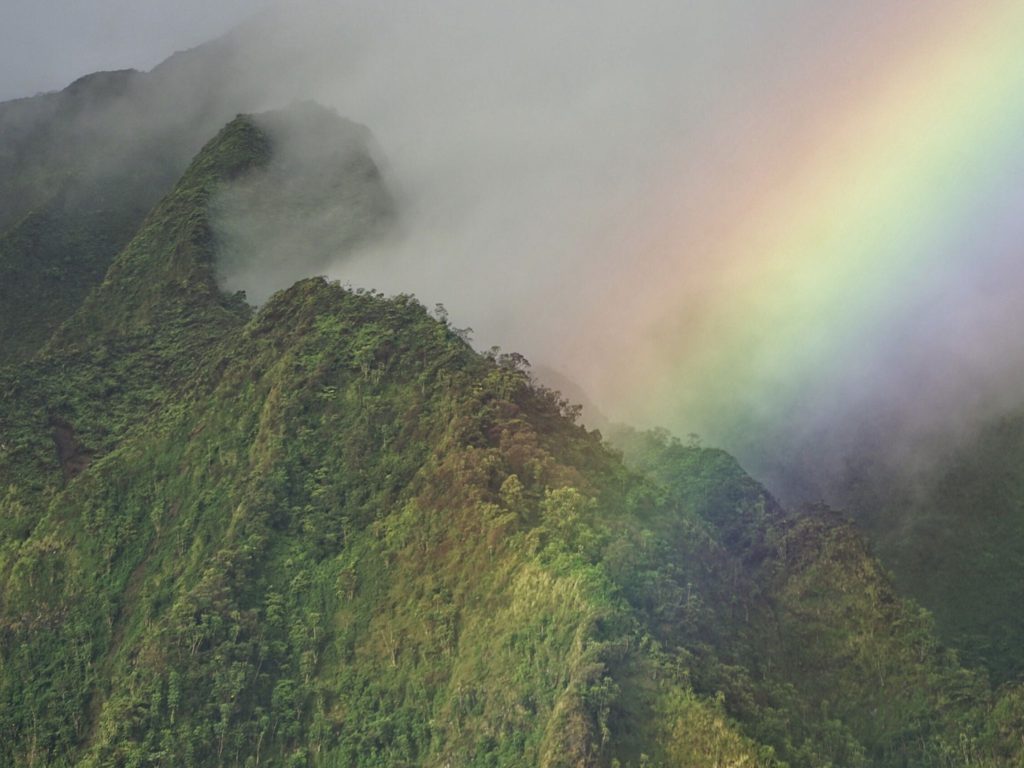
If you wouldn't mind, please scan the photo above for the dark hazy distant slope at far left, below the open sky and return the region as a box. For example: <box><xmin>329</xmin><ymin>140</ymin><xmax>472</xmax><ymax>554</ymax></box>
<box><xmin>0</xmin><ymin>20</ymin><xmax>337</xmax><ymax>364</ymax></box>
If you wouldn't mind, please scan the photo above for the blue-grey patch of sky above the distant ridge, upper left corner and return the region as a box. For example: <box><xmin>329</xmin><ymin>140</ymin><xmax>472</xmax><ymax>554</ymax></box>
<box><xmin>0</xmin><ymin>0</ymin><xmax>266</xmax><ymax>100</ymax></box>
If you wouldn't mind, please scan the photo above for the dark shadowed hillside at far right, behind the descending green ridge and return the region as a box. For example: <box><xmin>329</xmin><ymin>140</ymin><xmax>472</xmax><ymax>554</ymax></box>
<box><xmin>836</xmin><ymin>415</ymin><xmax>1024</xmax><ymax>681</ymax></box>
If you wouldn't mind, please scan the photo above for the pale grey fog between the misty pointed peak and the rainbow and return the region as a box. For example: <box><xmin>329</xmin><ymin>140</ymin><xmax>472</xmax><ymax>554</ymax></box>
<box><xmin>214</xmin><ymin>0</ymin><xmax>899</xmax><ymax>359</ymax></box>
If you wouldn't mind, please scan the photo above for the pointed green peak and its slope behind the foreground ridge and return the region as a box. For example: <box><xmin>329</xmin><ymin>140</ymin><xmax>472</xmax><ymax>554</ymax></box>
<box><xmin>0</xmin><ymin>102</ymin><xmax>380</xmax><ymax>573</ymax></box>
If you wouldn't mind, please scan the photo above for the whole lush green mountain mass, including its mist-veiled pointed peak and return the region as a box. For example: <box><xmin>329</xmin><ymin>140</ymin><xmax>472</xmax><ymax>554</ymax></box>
<box><xmin>0</xmin><ymin>67</ymin><xmax>1024</xmax><ymax>768</ymax></box>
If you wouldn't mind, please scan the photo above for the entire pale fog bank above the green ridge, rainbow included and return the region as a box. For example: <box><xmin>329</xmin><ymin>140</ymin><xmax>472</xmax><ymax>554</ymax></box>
<box><xmin>8</xmin><ymin>0</ymin><xmax>1022</xmax><ymax>499</ymax></box>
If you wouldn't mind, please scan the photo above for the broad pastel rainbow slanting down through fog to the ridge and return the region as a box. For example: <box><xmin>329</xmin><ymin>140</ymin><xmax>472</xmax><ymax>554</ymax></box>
<box><xmin>573</xmin><ymin>0</ymin><xmax>1024</xmax><ymax>442</ymax></box>
